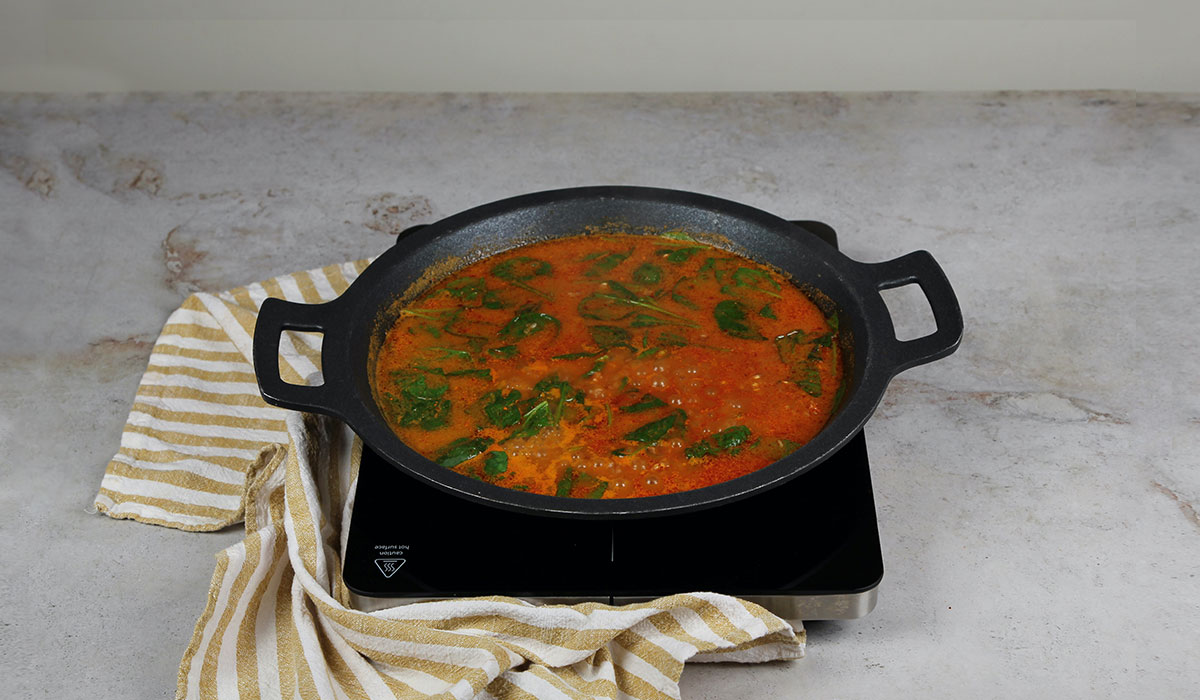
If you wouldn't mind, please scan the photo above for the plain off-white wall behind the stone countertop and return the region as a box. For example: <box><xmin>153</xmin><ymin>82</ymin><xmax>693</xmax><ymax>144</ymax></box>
<box><xmin>0</xmin><ymin>0</ymin><xmax>1200</xmax><ymax>91</ymax></box>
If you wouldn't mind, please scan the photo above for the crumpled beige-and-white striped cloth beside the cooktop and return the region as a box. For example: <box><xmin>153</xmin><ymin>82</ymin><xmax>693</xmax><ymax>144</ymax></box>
<box><xmin>96</xmin><ymin>261</ymin><xmax>804</xmax><ymax>699</ymax></box>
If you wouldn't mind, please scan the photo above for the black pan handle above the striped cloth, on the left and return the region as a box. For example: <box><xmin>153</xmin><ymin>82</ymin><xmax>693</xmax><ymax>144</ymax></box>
<box><xmin>254</xmin><ymin>298</ymin><xmax>340</xmax><ymax>415</ymax></box>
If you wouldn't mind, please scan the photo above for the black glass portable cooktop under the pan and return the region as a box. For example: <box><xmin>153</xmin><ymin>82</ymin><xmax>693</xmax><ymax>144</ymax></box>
<box><xmin>343</xmin><ymin>222</ymin><xmax>883</xmax><ymax>620</ymax></box>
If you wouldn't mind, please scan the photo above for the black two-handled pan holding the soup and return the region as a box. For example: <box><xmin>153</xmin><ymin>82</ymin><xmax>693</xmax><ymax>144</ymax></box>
<box><xmin>254</xmin><ymin>186</ymin><xmax>962</xmax><ymax>517</ymax></box>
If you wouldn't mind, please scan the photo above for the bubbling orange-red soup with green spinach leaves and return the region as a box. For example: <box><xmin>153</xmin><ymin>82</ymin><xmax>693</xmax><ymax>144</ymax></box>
<box><xmin>374</xmin><ymin>233</ymin><xmax>844</xmax><ymax>498</ymax></box>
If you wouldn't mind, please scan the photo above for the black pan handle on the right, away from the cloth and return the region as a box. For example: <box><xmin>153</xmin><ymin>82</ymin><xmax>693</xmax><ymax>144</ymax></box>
<box><xmin>866</xmin><ymin>251</ymin><xmax>962</xmax><ymax>373</ymax></box>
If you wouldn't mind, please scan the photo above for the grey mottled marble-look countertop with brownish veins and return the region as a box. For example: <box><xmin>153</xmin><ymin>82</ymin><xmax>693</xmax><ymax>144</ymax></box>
<box><xmin>0</xmin><ymin>92</ymin><xmax>1200</xmax><ymax>699</ymax></box>
